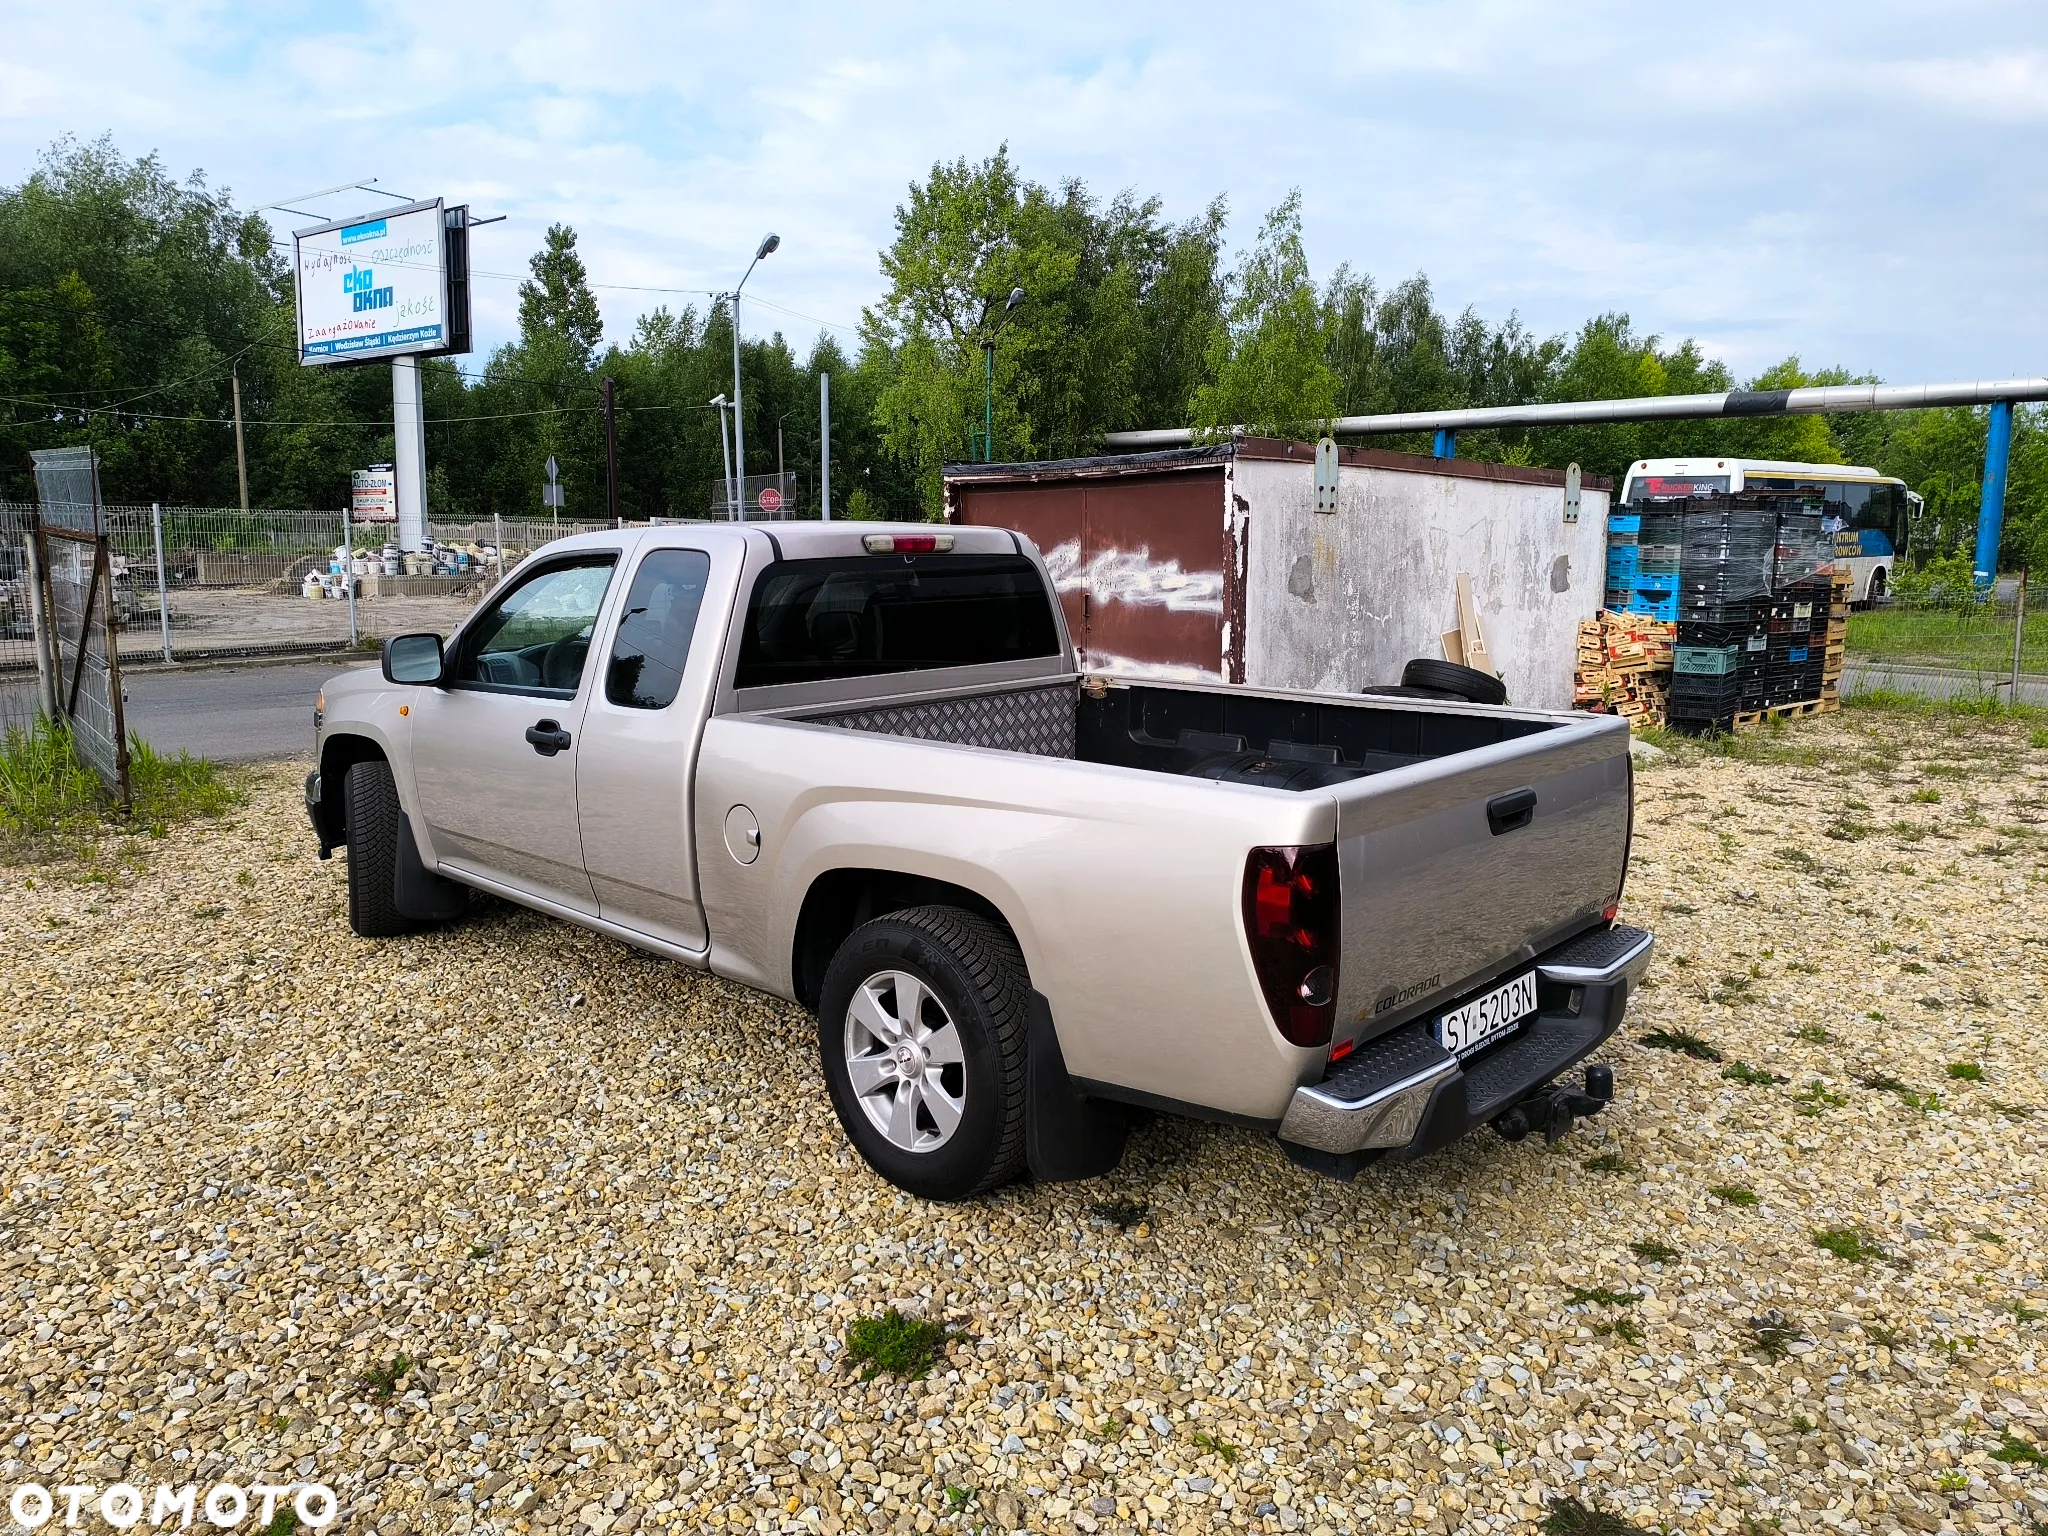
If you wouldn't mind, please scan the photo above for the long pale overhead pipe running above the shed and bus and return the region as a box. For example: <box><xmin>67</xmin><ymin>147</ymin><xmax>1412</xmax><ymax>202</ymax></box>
<box><xmin>1104</xmin><ymin>379</ymin><xmax>2048</xmax><ymax>453</ymax></box>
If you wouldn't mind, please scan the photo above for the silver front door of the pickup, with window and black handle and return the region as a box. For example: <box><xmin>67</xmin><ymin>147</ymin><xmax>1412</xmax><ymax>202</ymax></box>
<box><xmin>412</xmin><ymin>551</ymin><xmax>618</xmax><ymax>913</ymax></box>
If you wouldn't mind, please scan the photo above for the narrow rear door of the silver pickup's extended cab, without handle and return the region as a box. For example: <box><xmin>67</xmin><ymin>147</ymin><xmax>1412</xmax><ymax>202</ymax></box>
<box><xmin>575</xmin><ymin>535</ymin><xmax>743</xmax><ymax>950</ymax></box>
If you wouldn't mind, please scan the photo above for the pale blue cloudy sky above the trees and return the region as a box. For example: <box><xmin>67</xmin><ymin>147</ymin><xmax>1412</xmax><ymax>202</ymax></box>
<box><xmin>0</xmin><ymin>0</ymin><xmax>2048</xmax><ymax>409</ymax></box>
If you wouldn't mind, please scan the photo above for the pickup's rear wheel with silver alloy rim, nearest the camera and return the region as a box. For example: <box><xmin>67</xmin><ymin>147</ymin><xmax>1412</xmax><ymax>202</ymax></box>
<box><xmin>817</xmin><ymin>907</ymin><xmax>1030</xmax><ymax>1200</ymax></box>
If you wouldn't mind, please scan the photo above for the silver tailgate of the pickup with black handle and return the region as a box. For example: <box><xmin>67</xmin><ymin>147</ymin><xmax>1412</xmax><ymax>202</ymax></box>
<box><xmin>1335</xmin><ymin>717</ymin><xmax>1630</xmax><ymax>1040</ymax></box>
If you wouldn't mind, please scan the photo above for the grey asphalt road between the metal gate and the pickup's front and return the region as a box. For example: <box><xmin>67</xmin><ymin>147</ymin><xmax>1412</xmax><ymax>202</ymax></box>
<box><xmin>121</xmin><ymin>662</ymin><xmax>375</xmax><ymax>762</ymax></box>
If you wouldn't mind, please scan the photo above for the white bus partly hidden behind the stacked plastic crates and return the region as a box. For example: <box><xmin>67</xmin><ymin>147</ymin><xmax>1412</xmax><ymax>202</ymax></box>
<box><xmin>1620</xmin><ymin>459</ymin><xmax>1927</xmax><ymax>604</ymax></box>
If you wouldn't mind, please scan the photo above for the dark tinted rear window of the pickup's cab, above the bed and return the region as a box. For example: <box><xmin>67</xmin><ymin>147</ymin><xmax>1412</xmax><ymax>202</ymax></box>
<box><xmin>733</xmin><ymin>555</ymin><xmax>1059</xmax><ymax>688</ymax></box>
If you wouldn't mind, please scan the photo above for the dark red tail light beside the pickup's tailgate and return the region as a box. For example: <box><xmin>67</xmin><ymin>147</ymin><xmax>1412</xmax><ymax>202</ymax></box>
<box><xmin>1245</xmin><ymin>842</ymin><xmax>1337</xmax><ymax>1044</ymax></box>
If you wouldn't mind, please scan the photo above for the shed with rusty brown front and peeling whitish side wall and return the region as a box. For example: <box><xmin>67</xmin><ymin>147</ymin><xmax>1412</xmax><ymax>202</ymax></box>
<box><xmin>946</xmin><ymin>438</ymin><xmax>1610</xmax><ymax>709</ymax></box>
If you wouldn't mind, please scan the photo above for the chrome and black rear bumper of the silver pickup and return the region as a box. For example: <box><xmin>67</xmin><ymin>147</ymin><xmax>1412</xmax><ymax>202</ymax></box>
<box><xmin>1280</xmin><ymin>926</ymin><xmax>1655</xmax><ymax>1178</ymax></box>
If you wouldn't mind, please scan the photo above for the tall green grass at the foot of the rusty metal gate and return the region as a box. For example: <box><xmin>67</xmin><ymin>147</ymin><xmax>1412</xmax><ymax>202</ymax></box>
<box><xmin>0</xmin><ymin>721</ymin><xmax>242</xmax><ymax>864</ymax></box>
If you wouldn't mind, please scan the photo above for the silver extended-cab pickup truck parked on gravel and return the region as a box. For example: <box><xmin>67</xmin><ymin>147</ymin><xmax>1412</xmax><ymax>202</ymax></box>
<box><xmin>305</xmin><ymin>522</ymin><xmax>1651</xmax><ymax>1198</ymax></box>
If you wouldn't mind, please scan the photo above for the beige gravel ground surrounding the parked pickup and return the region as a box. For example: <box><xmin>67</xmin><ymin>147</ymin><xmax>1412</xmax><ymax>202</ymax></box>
<box><xmin>0</xmin><ymin>713</ymin><xmax>2048</xmax><ymax>1536</ymax></box>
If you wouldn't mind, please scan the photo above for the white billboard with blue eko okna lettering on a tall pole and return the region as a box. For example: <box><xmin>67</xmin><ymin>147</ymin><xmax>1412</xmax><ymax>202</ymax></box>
<box><xmin>293</xmin><ymin>197</ymin><xmax>469</xmax><ymax>367</ymax></box>
